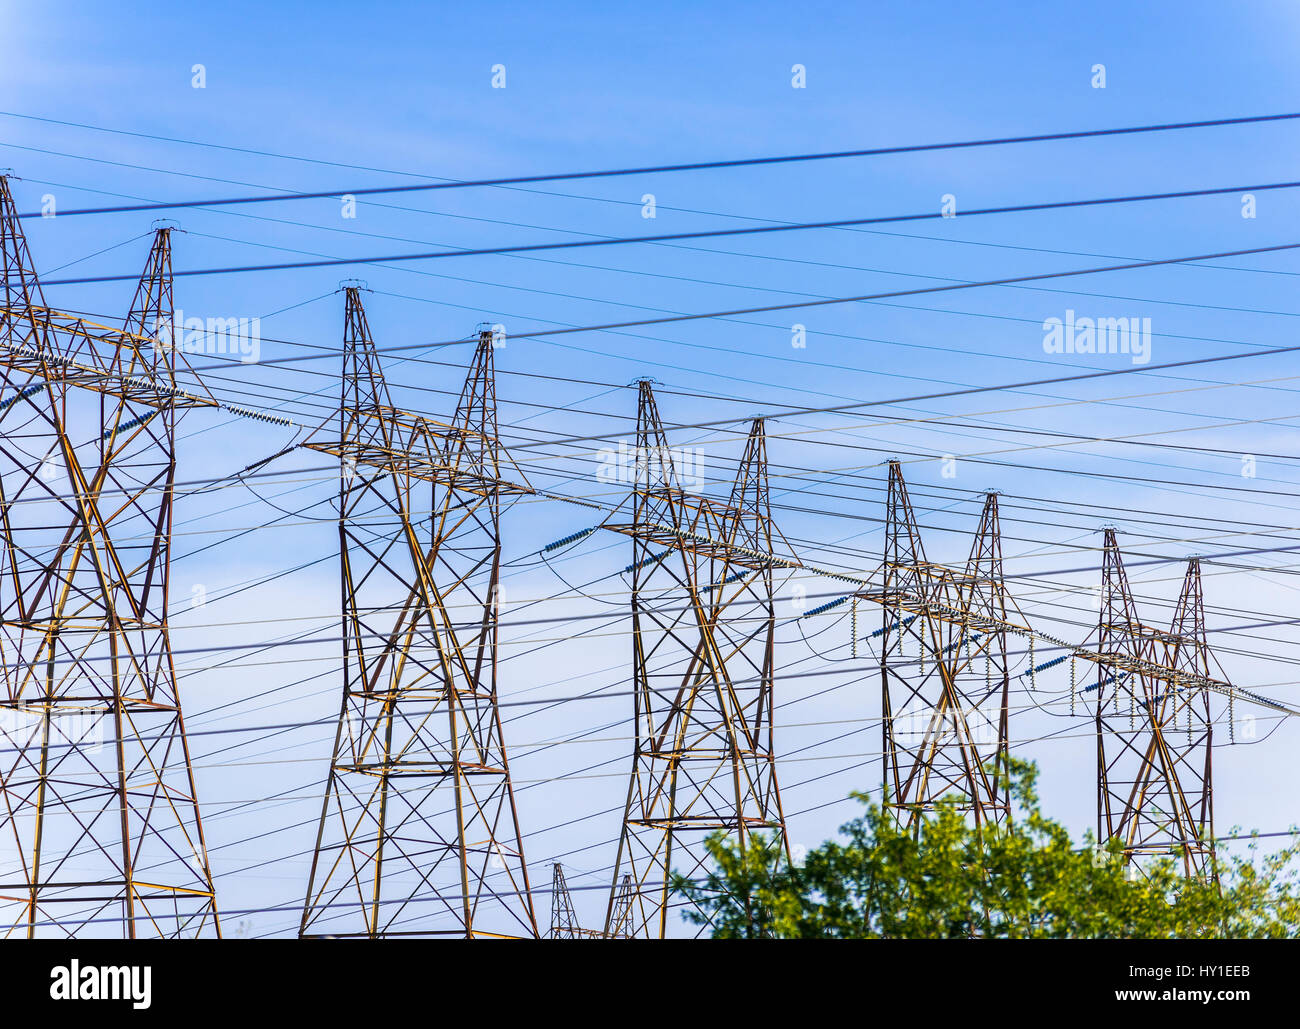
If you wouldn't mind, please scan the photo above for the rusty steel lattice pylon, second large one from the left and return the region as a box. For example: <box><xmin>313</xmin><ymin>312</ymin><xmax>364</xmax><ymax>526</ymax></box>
<box><xmin>299</xmin><ymin>287</ymin><xmax>538</xmax><ymax>937</ymax></box>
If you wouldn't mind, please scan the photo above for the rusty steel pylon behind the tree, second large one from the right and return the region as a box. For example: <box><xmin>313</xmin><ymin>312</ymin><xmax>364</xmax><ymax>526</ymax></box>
<box><xmin>861</xmin><ymin>461</ymin><xmax>1019</xmax><ymax>828</ymax></box>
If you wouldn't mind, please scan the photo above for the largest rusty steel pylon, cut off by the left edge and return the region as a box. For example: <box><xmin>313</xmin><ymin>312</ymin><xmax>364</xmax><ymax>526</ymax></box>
<box><xmin>0</xmin><ymin>178</ymin><xmax>221</xmax><ymax>938</ymax></box>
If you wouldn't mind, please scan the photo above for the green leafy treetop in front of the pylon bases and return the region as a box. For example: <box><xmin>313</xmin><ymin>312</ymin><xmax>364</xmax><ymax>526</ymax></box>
<box><xmin>673</xmin><ymin>761</ymin><xmax>1300</xmax><ymax>939</ymax></box>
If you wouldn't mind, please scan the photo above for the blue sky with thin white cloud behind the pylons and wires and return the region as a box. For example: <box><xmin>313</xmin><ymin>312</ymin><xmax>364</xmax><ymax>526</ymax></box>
<box><xmin>0</xmin><ymin>3</ymin><xmax>1300</xmax><ymax>934</ymax></box>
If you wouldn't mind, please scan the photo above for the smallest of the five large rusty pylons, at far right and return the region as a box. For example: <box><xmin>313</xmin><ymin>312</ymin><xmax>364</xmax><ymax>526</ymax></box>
<box><xmin>1095</xmin><ymin>529</ymin><xmax>1226</xmax><ymax>881</ymax></box>
